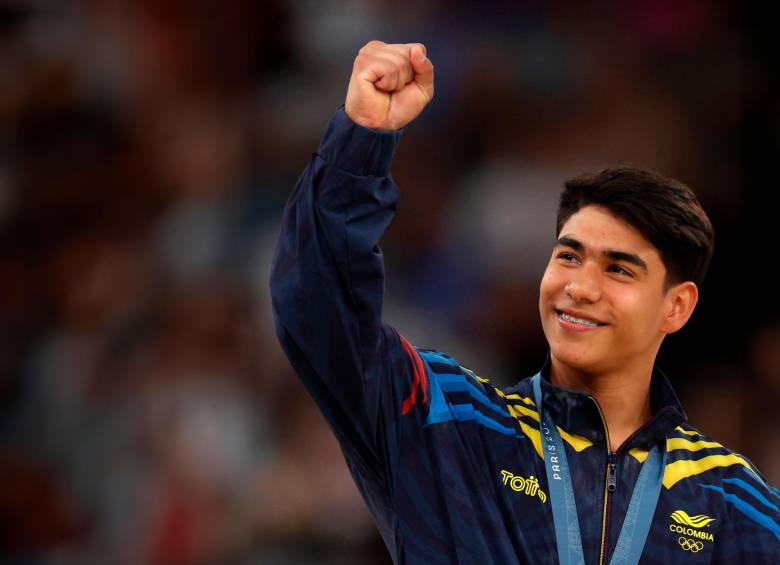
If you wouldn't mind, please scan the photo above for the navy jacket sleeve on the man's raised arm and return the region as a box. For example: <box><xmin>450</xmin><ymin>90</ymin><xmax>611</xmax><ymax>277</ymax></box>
<box><xmin>270</xmin><ymin>107</ymin><xmax>425</xmax><ymax>484</ymax></box>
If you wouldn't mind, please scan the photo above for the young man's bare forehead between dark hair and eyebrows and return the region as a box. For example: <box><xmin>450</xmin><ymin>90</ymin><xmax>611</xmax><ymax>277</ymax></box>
<box><xmin>559</xmin><ymin>205</ymin><xmax>662</xmax><ymax>264</ymax></box>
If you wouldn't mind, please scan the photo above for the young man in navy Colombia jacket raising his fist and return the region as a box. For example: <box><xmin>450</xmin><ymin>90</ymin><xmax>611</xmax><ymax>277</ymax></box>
<box><xmin>271</xmin><ymin>41</ymin><xmax>780</xmax><ymax>565</ymax></box>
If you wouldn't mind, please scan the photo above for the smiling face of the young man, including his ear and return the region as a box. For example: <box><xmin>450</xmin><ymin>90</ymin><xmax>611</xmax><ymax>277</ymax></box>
<box><xmin>539</xmin><ymin>205</ymin><xmax>698</xmax><ymax>374</ymax></box>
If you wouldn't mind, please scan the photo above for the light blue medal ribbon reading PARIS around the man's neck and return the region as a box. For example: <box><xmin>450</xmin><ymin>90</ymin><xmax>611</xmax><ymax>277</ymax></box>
<box><xmin>531</xmin><ymin>373</ymin><xmax>666</xmax><ymax>565</ymax></box>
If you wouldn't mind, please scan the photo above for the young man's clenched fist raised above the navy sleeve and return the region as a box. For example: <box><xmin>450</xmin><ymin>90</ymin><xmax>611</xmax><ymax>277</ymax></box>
<box><xmin>344</xmin><ymin>41</ymin><xmax>433</xmax><ymax>130</ymax></box>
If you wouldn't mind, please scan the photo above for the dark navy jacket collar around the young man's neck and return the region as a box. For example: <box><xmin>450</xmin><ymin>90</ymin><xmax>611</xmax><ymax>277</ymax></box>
<box><xmin>522</xmin><ymin>351</ymin><xmax>687</xmax><ymax>449</ymax></box>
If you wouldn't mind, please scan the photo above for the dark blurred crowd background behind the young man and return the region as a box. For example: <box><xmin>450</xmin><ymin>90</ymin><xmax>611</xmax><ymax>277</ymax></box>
<box><xmin>0</xmin><ymin>0</ymin><xmax>780</xmax><ymax>565</ymax></box>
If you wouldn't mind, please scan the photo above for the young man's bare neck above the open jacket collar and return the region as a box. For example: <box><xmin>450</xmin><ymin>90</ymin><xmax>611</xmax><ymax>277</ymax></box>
<box><xmin>550</xmin><ymin>358</ymin><xmax>652</xmax><ymax>451</ymax></box>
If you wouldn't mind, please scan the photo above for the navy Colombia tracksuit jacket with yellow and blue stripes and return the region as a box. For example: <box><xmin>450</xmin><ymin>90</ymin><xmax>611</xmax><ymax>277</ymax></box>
<box><xmin>271</xmin><ymin>107</ymin><xmax>780</xmax><ymax>565</ymax></box>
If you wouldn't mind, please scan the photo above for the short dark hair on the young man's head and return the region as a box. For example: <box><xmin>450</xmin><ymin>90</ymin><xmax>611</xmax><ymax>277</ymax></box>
<box><xmin>556</xmin><ymin>167</ymin><xmax>715</xmax><ymax>290</ymax></box>
